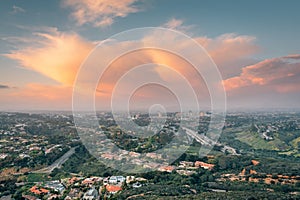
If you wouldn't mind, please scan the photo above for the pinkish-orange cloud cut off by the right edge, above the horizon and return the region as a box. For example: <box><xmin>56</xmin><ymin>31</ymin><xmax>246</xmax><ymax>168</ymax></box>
<box><xmin>223</xmin><ymin>55</ymin><xmax>300</xmax><ymax>92</ymax></box>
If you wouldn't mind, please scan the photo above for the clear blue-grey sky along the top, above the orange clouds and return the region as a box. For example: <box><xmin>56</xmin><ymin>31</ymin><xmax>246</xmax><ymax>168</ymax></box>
<box><xmin>0</xmin><ymin>0</ymin><xmax>300</xmax><ymax>57</ymax></box>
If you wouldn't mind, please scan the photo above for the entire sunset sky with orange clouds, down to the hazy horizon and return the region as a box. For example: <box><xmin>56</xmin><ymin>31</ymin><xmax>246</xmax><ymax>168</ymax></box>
<box><xmin>0</xmin><ymin>0</ymin><xmax>300</xmax><ymax>110</ymax></box>
